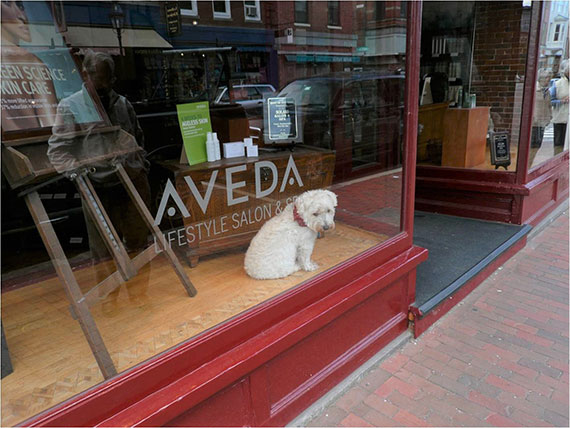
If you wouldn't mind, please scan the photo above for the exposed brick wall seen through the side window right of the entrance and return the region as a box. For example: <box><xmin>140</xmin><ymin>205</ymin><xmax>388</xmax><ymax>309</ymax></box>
<box><xmin>471</xmin><ymin>2</ymin><xmax>530</xmax><ymax>145</ymax></box>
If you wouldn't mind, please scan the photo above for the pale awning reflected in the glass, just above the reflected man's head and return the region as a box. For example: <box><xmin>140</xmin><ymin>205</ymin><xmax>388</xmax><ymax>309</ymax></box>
<box><xmin>66</xmin><ymin>26</ymin><xmax>172</xmax><ymax>48</ymax></box>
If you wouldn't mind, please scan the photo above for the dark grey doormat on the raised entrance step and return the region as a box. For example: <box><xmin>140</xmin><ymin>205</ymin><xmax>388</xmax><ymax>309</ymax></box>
<box><xmin>413</xmin><ymin>211</ymin><xmax>531</xmax><ymax>314</ymax></box>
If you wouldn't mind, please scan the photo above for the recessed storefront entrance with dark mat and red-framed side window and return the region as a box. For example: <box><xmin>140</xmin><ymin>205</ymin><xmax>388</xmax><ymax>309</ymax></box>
<box><xmin>411</xmin><ymin>1</ymin><xmax>568</xmax><ymax>336</ymax></box>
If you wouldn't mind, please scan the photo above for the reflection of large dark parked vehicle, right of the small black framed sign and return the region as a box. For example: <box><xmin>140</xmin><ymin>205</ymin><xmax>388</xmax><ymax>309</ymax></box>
<box><xmin>278</xmin><ymin>73</ymin><xmax>405</xmax><ymax>181</ymax></box>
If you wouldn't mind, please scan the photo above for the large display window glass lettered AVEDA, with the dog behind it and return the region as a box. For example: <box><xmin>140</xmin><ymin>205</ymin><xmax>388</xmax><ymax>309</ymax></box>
<box><xmin>1</xmin><ymin>1</ymin><xmax>406</xmax><ymax>426</ymax></box>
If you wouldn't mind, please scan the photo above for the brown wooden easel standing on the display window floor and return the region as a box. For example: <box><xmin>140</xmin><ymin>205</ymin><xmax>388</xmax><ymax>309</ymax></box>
<box><xmin>2</xmin><ymin>129</ymin><xmax>197</xmax><ymax>379</ymax></box>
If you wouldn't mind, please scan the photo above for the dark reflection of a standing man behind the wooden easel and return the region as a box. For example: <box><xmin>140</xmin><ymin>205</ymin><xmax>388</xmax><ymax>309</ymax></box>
<box><xmin>48</xmin><ymin>52</ymin><xmax>150</xmax><ymax>310</ymax></box>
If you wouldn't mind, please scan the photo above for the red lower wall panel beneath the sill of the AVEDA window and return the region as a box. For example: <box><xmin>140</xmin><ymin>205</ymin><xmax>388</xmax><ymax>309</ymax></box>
<box><xmin>164</xmin><ymin>264</ymin><xmax>420</xmax><ymax>426</ymax></box>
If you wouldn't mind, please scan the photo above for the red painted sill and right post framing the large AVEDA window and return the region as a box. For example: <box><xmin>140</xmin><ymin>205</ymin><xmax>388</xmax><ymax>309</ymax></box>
<box><xmin>20</xmin><ymin>2</ymin><xmax>426</xmax><ymax>426</ymax></box>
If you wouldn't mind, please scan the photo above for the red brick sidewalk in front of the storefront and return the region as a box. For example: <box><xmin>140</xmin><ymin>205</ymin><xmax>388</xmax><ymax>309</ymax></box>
<box><xmin>309</xmin><ymin>211</ymin><xmax>569</xmax><ymax>427</ymax></box>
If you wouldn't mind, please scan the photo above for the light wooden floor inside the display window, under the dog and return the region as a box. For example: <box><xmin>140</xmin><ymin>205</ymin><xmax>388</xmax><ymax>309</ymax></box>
<box><xmin>2</xmin><ymin>223</ymin><xmax>388</xmax><ymax>426</ymax></box>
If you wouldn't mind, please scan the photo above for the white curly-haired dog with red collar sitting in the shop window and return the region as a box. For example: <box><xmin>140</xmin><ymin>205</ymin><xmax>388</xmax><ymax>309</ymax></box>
<box><xmin>244</xmin><ymin>190</ymin><xmax>337</xmax><ymax>279</ymax></box>
